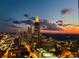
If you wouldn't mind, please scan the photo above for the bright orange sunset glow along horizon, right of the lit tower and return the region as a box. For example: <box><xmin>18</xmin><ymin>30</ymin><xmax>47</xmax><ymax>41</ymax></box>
<box><xmin>41</xmin><ymin>26</ymin><xmax>79</xmax><ymax>34</ymax></box>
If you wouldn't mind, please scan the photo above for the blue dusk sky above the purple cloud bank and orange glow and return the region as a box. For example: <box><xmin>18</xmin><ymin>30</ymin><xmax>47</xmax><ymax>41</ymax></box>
<box><xmin>0</xmin><ymin>0</ymin><xmax>79</xmax><ymax>31</ymax></box>
